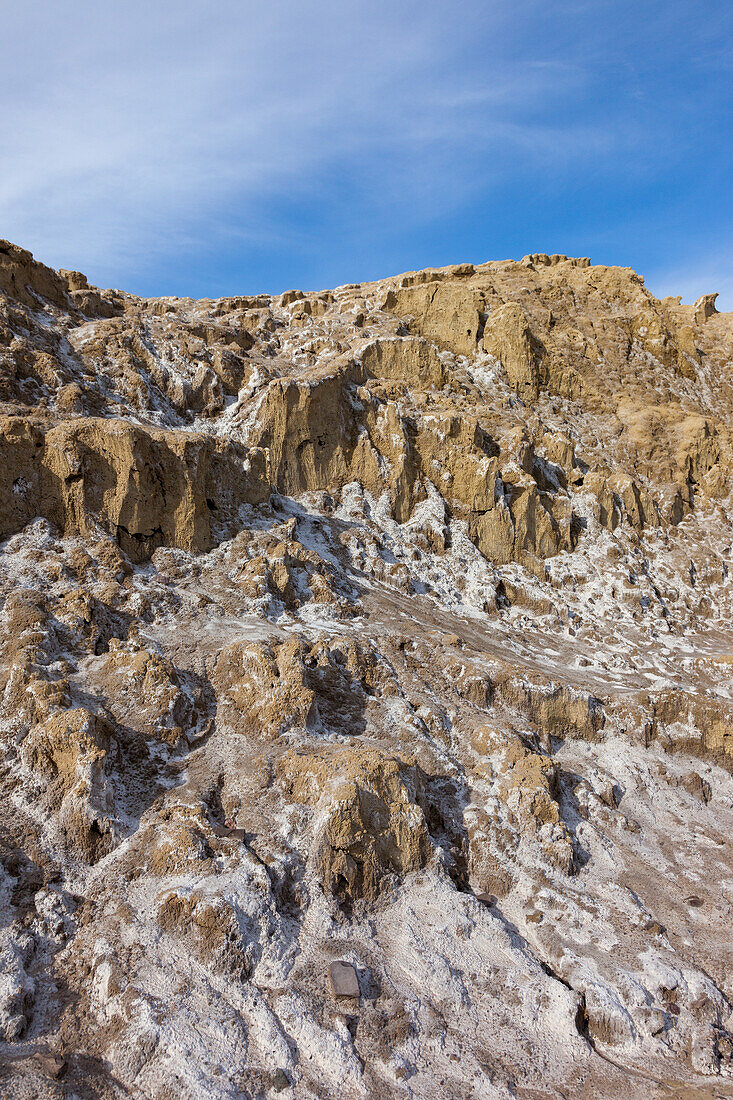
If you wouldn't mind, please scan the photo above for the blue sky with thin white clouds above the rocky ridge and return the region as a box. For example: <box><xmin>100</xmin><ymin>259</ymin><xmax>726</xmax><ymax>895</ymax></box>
<box><xmin>0</xmin><ymin>0</ymin><xmax>733</xmax><ymax>309</ymax></box>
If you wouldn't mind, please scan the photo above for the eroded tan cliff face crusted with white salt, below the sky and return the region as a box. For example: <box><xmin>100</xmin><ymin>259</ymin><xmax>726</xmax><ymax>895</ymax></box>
<box><xmin>0</xmin><ymin>242</ymin><xmax>733</xmax><ymax>1100</ymax></box>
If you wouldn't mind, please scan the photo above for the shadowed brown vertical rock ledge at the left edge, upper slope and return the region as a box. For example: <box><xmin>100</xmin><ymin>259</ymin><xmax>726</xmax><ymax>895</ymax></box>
<box><xmin>0</xmin><ymin>418</ymin><xmax>270</xmax><ymax>561</ymax></box>
